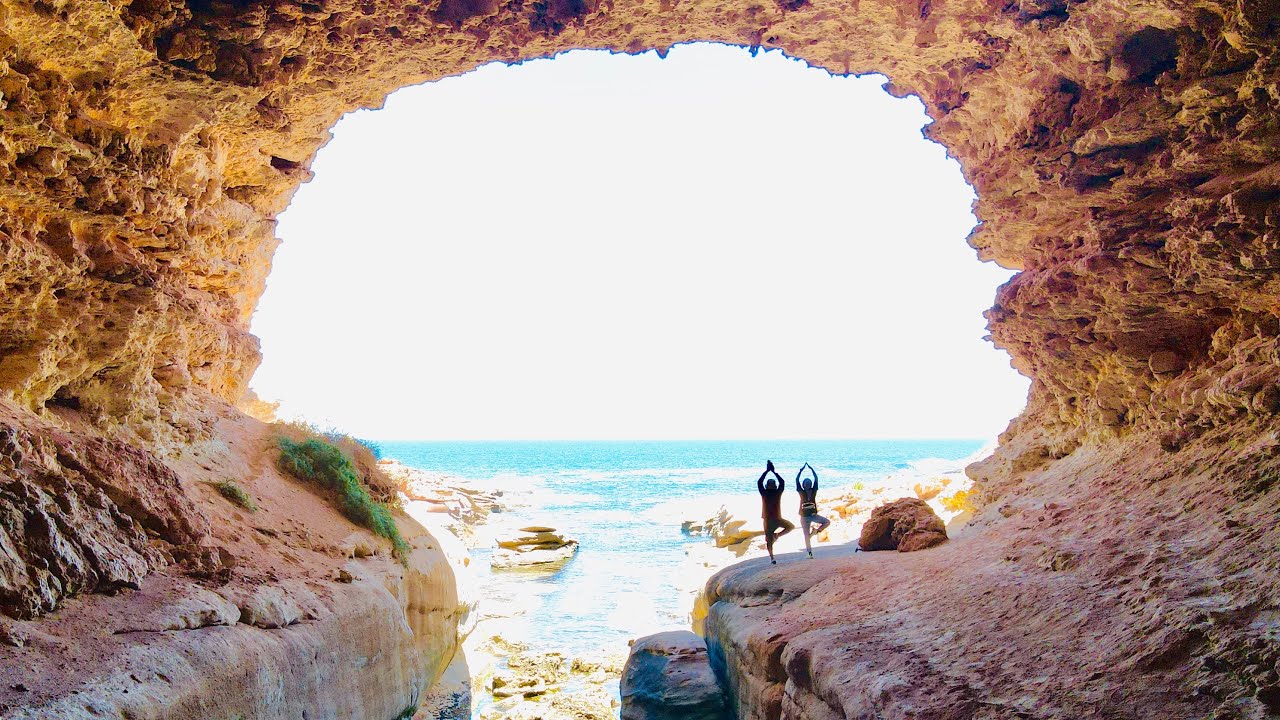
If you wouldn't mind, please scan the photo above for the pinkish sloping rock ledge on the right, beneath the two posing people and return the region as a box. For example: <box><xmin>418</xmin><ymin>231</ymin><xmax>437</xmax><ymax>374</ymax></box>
<box><xmin>704</xmin><ymin>427</ymin><xmax>1280</xmax><ymax>720</ymax></box>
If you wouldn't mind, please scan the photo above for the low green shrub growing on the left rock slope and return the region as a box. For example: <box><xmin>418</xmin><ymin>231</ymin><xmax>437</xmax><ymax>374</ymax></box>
<box><xmin>278</xmin><ymin>437</ymin><xmax>408</xmax><ymax>562</ymax></box>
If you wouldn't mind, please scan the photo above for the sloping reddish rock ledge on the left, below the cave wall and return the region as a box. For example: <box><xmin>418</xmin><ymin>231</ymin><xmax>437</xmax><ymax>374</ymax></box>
<box><xmin>0</xmin><ymin>404</ymin><xmax>470</xmax><ymax>720</ymax></box>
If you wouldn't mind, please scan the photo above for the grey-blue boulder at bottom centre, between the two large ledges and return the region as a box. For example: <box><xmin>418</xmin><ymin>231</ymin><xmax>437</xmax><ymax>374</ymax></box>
<box><xmin>621</xmin><ymin>630</ymin><xmax>728</xmax><ymax>720</ymax></box>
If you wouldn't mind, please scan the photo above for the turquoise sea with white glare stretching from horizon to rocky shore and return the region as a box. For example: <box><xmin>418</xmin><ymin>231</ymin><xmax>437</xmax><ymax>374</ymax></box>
<box><xmin>379</xmin><ymin>439</ymin><xmax>983</xmax><ymax>655</ymax></box>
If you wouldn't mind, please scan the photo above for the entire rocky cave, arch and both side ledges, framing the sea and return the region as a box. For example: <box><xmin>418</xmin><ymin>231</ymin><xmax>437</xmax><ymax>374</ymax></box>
<box><xmin>0</xmin><ymin>0</ymin><xmax>1280</xmax><ymax>719</ymax></box>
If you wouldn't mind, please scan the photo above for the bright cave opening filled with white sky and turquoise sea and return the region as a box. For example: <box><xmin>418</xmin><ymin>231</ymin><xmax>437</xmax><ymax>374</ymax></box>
<box><xmin>253</xmin><ymin>44</ymin><xmax>1027</xmax><ymax>714</ymax></box>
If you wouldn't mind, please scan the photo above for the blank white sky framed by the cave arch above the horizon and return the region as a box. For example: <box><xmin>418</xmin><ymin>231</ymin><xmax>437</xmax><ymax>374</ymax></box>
<box><xmin>253</xmin><ymin>45</ymin><xmax>1028</xmax><ymax>439</ymax></box>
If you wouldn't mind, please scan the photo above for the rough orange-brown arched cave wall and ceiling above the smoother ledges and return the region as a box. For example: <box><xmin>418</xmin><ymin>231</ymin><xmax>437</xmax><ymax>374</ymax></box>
<box><xmin>0</xmin><ymin>0</ymin><xmax>1280</xmax><ymax>454</ymax></box>
